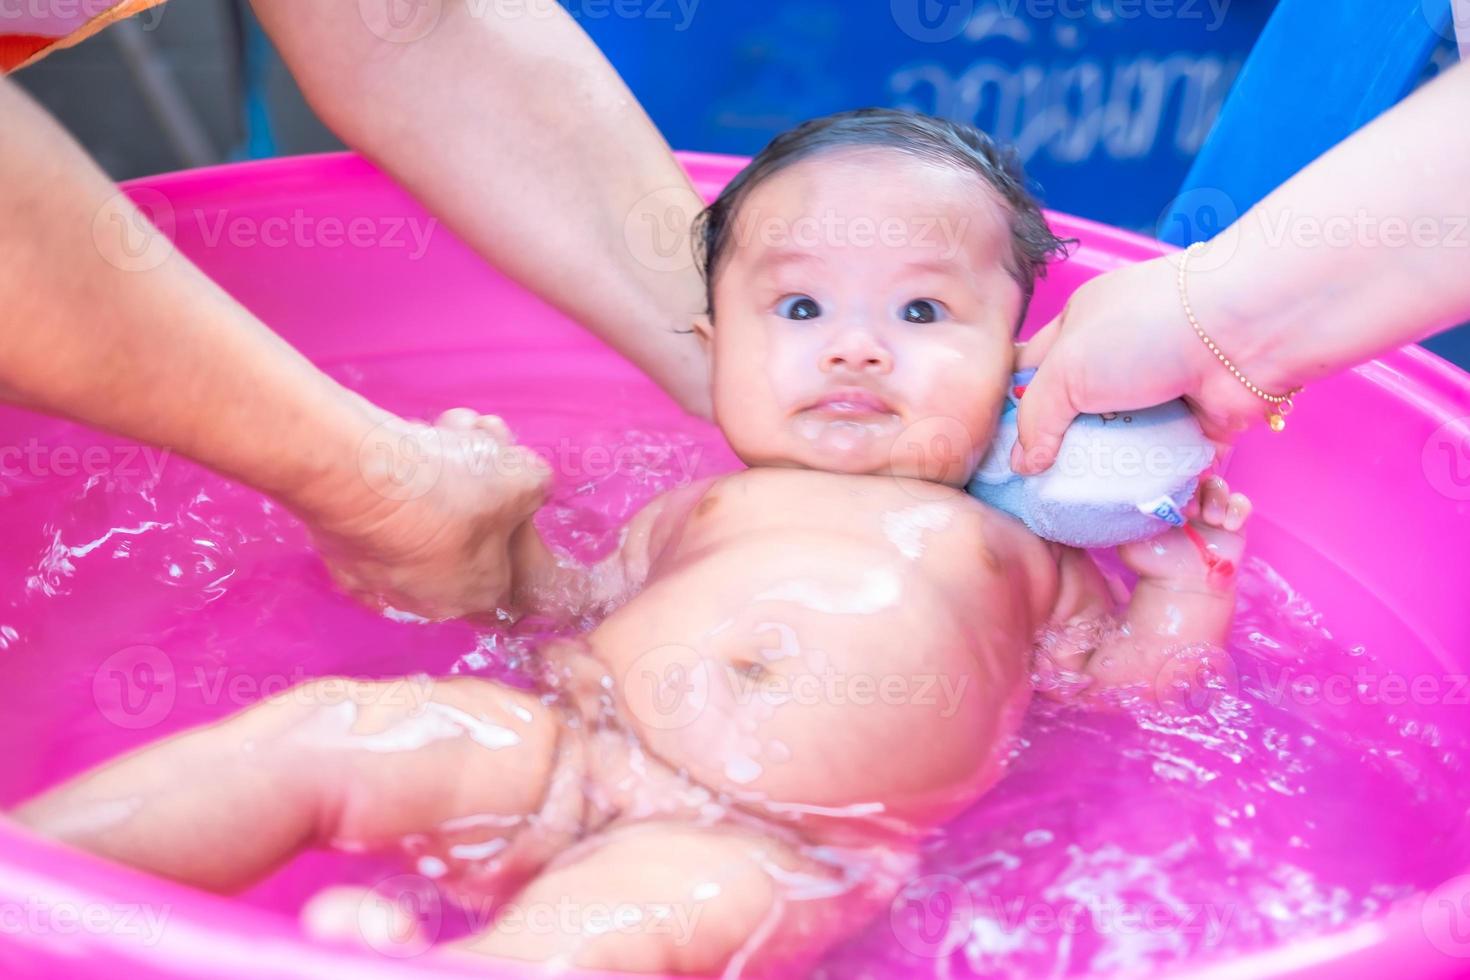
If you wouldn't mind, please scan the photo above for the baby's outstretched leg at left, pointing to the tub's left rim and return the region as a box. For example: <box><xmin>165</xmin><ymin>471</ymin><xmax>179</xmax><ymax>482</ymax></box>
<box><xmin>13</xmin><ymin>677</ymin><xmax>562</xmax><ymax>892</ymax></box>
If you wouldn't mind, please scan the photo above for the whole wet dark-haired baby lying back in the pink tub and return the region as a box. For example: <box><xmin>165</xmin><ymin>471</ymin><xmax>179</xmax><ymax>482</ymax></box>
<box><xmin>16</xmin><ymin>110</ymin><xmax>1250</xmax><ymax>976</ymax></box>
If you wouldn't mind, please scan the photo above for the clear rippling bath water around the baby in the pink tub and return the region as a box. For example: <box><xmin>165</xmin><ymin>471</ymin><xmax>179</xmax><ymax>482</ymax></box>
<box><xmin>0</xmin><ymin>356</ymin><xmax>1470</xmax><ymax>979</ymax></box>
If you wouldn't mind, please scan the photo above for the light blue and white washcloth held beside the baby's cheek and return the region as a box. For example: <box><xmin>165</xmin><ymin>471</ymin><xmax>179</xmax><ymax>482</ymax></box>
<box><xmin>967</xmin><ymin>369</ymin><xmax>1214</xmax><ymax>548</ymax></box>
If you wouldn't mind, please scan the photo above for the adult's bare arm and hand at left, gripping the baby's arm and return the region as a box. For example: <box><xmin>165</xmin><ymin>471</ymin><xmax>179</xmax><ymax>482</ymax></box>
<box><xmin>0</xmin><ymin>89</ymin><xmax>548</xmax><ymax>617</ymax></box>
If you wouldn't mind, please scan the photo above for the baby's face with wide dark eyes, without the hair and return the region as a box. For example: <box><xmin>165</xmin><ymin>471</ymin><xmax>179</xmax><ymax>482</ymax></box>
<box><xmin>700</xmin><ymin>150</ymin><xmax>1022</xmax><ymax>486</ymax></box>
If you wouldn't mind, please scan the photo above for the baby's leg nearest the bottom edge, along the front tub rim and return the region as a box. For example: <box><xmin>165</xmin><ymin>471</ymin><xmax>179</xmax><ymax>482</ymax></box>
<box><xmin>456</xmin><ymin>821</ymin><xmax>897</xmax><ymax>976</ymax></box>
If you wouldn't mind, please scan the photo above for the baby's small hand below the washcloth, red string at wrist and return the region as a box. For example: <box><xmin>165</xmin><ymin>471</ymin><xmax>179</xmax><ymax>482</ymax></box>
<box><xmin>1119</xmin><ymin>476</ymin><xmax>1251</xmax><ymax>592</ymax></box>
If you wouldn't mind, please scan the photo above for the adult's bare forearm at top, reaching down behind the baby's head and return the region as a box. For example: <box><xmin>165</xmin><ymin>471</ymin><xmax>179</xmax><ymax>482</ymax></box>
<box><xmin>254</xmin><ymin>0</ymin><xmax>709</xmax><ymax>413</ymax></box>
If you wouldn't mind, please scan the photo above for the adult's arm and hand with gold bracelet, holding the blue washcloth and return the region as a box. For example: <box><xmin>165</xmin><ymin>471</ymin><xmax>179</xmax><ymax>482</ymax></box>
<box><xmin>1013</xmin><ymin>65</ymin><xmax>1470</xmax><ymax>473</ymax></box>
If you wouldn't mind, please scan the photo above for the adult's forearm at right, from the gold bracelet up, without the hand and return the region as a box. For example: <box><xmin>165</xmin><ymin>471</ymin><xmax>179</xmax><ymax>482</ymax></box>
<box><xmin>1191</xmin><ymin>59</ymin><xmax>1470</xmax><ymax>383</ymax></box>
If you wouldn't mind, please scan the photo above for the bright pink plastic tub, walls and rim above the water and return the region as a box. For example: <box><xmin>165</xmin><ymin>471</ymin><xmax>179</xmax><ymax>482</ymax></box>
<box><xmin>0</xmin><ymin>154</ymin><xmax>1470</xmax><ymax>980</ymax></box>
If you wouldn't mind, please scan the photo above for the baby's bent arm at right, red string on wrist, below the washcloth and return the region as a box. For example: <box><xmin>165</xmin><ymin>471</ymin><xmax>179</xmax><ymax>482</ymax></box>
<box><xmin>1050</xmin><ymin>476</ymin><xmax>1251</xmax><ymax>698</ymax></box>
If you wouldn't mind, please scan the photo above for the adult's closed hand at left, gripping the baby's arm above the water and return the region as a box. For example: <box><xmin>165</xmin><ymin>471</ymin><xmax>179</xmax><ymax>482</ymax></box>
<box><xmin>303</xmin><ymin>408</ymin><xmax>551</xmax><ymax>620</ymax></box>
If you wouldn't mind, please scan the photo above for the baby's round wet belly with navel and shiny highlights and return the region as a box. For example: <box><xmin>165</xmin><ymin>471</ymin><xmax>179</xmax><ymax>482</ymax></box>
<box><xmin>588</xmin><ymin>536</ymin><xmax>1029</xmax><ymax>835</ymax></box>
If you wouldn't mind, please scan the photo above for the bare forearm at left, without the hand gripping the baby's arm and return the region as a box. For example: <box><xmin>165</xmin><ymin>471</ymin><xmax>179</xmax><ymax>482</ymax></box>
<box><xmin>0</xmin><ymin>79</ymin><xmax>373</xmax><ymax>510</ymax></box>
